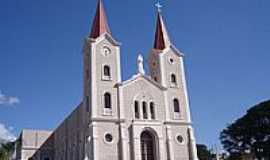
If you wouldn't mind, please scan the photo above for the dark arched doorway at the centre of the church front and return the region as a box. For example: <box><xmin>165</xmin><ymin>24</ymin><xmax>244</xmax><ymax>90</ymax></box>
<box><xmin>141</xmin><ymin>131</ymin><xmax>156</xmax><ymax>160</ymax></box>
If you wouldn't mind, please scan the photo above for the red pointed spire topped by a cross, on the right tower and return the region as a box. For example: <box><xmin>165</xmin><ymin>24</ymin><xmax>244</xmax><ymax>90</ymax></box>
<box><xmin>154</xmin><ymin>10</ymin><xmax>171</xmax><ymax>50</ymax></box>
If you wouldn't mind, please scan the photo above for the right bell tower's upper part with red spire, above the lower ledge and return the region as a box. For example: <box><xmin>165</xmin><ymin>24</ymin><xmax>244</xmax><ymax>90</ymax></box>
<box><xmin>148</xmin><ymin>7</ymin><xmax>190</xmax><ymax>122</ymax></box>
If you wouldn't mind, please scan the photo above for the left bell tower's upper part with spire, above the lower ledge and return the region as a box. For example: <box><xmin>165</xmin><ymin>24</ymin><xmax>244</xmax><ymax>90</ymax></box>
<box><xmin>83</xmin><ymin>0</ymin><xmax>121</xmax><ymax>118</ymax></box>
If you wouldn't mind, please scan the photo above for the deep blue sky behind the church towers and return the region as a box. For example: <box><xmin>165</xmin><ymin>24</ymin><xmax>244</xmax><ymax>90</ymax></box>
<box><xmin>0</xmin><ymin>0</ymin><xmax>270</xmax><ymax>149</ymax></box>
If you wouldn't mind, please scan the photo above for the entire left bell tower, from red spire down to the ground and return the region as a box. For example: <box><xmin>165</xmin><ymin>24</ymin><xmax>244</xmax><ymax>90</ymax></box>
<box><xmin>83</xmin><ymin>0</ymin><xmax>121</xmax><ymax>160</ymax></box>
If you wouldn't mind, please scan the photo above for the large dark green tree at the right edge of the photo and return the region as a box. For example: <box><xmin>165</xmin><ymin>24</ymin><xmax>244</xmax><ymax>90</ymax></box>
<box><xmin>220</xmin><ymin>100</ymin><xmax>270</xmax><ymax>159</ymax></box>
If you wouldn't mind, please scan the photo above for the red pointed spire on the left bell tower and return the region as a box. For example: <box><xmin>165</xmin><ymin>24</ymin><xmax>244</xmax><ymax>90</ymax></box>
<box><xmin>90</xmin><ymin>0</ymin><xmax>111</xmax><ymax>38</ymax></box>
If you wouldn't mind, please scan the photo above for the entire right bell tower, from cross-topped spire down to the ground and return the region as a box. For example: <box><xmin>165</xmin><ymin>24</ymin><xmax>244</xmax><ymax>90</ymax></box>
<box><xmin>148</xmin><ymin>5</ymin><xmax>198</xmax><ymax>160</ymax></box>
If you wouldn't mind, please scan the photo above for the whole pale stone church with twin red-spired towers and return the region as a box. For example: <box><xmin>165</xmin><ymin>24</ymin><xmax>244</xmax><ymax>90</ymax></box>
<box><xmin>15</xmin><ymin>0</ymin><xmax>198</xmax><ymax>160</ymax></box>
